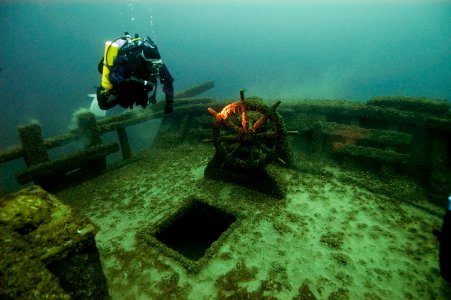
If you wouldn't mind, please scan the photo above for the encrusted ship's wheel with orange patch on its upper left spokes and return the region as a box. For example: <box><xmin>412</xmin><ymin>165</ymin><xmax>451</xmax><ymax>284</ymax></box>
<box><xmin>208</xmin><ymin>90</ymin><xmax>287</xmax><ymax>169</ymax></box>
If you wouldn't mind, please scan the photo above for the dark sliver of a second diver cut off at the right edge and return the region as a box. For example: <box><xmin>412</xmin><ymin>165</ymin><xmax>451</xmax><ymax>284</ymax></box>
<box><xmin>433</xmin><ymin>195</ymin><xmax>451</xmax><ymax>284</ymax></box>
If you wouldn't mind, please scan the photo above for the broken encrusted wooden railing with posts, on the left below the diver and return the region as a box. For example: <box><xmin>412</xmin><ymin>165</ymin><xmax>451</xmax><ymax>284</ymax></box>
<box><xmin>0</xmin><ymin>81</ymin><xmax>214</xmax><ymax>187</ymax></box>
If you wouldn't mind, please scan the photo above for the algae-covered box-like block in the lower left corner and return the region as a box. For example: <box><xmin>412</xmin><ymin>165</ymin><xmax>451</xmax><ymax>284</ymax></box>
<box><xmin>0</xmin><ymin>186</ymin><xmax>108</xmax><ymax>299</ymax></box>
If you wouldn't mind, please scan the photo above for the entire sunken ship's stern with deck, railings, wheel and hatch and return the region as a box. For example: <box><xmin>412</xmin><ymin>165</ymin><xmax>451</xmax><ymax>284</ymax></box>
<box><xmin>0</xmin><ymin>82</ymin><xmax>451</xmax><ymax>299</ymax></box>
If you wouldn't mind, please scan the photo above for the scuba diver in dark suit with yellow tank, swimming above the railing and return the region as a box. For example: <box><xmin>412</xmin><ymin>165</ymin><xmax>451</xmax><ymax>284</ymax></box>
<box><xmin>91</xmin><ymin>32</ymin><xmax>174</xmax><ymax>116</ymax></box>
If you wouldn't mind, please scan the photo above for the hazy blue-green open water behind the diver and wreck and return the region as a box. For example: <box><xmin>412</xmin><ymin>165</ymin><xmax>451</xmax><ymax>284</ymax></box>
<box><xmin>0</xmin><ymin>0</ymin><xmax>451</xmax><ymax>192</ymax></box>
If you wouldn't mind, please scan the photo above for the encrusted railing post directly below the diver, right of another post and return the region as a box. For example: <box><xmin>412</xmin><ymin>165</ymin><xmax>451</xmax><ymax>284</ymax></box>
<box><xmin>77</xmin><ymin>112</ymin><xmax>106</xmax><ymax>173</ymax></box>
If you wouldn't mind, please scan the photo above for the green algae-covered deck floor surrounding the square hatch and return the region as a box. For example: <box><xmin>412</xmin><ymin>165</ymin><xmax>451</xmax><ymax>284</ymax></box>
<box><xmin>58</xmin><ymin>144</ymin><xmax>451</xmax><ymax>299</ymax></box>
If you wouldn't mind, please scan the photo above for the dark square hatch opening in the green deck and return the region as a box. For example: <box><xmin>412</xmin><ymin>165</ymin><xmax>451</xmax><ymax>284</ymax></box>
<box><xmin>155</xmin><ymin>200</ymin><xmax>236</xmax><ymax>260</ymax></box>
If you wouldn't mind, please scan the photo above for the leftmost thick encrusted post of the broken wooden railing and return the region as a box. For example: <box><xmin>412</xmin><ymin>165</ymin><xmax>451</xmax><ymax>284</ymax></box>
<box><xmin>17</xmin><ymin>121</ymin><xmax>49</xmax><ymax>167</ymax></box>
